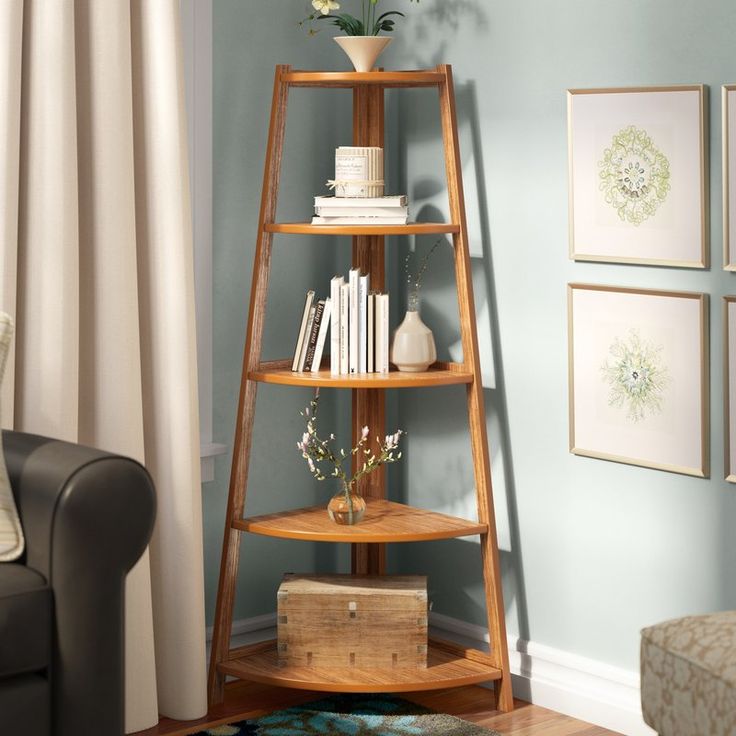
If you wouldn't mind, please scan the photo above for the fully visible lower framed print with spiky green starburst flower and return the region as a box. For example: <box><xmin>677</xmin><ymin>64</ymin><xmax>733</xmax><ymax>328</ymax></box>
<box><xmin>568</xmin><ymin>284</ymin><xmax>709</xmax><ymax>478</ymax></box>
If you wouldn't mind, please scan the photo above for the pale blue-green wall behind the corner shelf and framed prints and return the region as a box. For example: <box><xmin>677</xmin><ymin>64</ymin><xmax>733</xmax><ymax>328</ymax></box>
<box><xmin>210</xmin><ymin>0</ymin><xmax>736</xmax><ymax>670</ymax></box>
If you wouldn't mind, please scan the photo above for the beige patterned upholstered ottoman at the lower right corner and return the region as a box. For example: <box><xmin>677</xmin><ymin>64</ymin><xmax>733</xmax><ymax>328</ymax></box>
<box><xmin>641</xmin><ymin>611</ymin><xmax>736</xmax><ymax>736</ymax></box>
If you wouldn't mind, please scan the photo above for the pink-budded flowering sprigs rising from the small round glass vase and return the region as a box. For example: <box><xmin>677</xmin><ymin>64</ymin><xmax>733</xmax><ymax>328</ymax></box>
<box><xmin>296</xmin><ymin>390</ymin><xmax>404</xmax><ymax>500</ymax></box>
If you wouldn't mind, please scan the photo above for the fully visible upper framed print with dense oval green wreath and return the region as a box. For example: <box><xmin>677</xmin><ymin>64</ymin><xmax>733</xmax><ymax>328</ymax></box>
<box><xmin>567</xmin><ymin>85</ymin><xmax>708</xmax><ymax>268</ymax></box>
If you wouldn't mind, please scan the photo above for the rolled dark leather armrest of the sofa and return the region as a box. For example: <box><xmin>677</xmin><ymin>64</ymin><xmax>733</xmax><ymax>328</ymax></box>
<box><xmin>3</xmin><ymin>431</ymin><xmax>155</xmax><ymax>736</ymax></box>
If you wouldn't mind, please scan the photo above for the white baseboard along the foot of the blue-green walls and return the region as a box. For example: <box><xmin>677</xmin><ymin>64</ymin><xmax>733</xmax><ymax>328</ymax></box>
<box><xmin>207</xmin><ymin>613</ymin><xmax>656</xmax><ymax>736</ymax></box>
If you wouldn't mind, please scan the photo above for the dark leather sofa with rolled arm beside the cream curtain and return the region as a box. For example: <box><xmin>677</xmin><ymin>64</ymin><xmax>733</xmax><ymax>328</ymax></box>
<box><xmin>0</xmin><ymin>432</ymin><xmax>156</xmax><ymax>736</ymax></box>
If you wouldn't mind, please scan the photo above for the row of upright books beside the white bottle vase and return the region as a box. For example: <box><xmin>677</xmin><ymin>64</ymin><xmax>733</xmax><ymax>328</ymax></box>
<box><xmin>291</xmin><ymin>268</ymin><xmax>389</xmax><ymax>375</ymax></box>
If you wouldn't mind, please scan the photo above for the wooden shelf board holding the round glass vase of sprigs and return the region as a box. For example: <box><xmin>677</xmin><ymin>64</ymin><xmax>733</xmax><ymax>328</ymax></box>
<box><xmin>233</xmin><ymin>499</ymin><xmax>488</xmax><ymax>544</ymax></box>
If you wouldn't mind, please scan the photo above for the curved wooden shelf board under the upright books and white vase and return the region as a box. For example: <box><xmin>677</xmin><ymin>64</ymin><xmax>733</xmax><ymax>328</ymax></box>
<box><xmin>248</xmin><ymin>360</ymin><xmax>473</xmax><ymax>388</ymax></box>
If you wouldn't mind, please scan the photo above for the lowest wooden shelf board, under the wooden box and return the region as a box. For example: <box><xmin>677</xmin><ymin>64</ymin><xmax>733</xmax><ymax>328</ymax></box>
<box><xmin>217</xmin><ymin>639</ymin><xmax>502</xmax><ymax>693</ymax></box>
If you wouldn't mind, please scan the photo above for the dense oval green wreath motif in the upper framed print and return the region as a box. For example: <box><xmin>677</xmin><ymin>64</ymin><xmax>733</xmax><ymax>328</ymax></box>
<box><xmin>598</xmin><ymin>125</ymin><xmax>670</xmax><ymax>226</ymax></box>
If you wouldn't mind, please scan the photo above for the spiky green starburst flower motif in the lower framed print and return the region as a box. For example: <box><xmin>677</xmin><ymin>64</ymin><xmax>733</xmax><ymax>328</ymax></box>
<box><xmin>601</xmin><ymin>329</ymin><xmax>670</xmax><ymax>423</ymax></box>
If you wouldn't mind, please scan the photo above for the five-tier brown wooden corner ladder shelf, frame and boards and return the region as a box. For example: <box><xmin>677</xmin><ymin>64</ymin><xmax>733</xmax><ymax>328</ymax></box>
<box><xmin>209</xmin><ymin>65</ymin><xmax>513</xmax><ymax>711</ymax></box>
